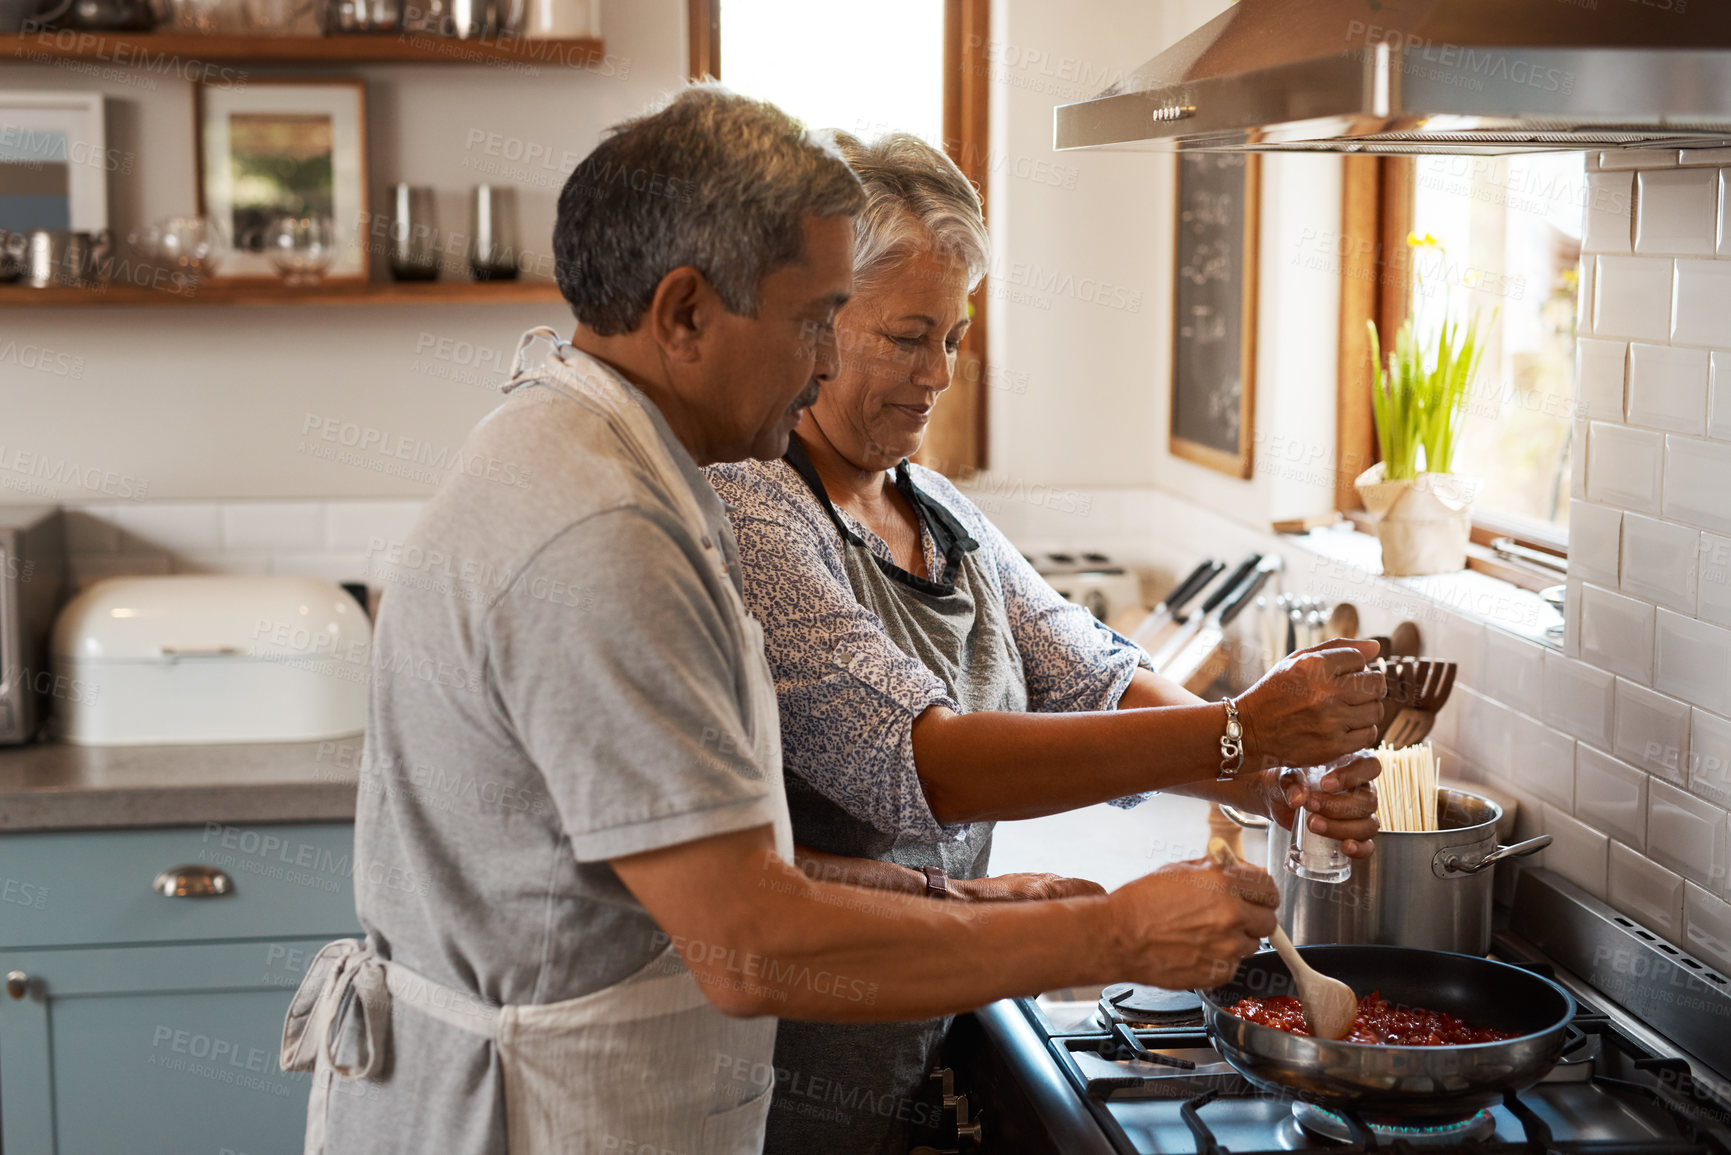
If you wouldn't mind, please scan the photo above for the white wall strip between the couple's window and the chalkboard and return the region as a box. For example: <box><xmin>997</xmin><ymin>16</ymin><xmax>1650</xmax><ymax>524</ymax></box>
<box><xmin>988</xmin><ymin>0</ymin><xmax>1174</xmax><ymax>487</ymax></box>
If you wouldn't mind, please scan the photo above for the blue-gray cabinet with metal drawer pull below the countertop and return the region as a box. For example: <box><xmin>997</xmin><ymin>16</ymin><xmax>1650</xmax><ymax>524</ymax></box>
<box><xmin>0</xmin><ymin>824</ymin><xmax>360</xmax><ymax>1155</ymax></box>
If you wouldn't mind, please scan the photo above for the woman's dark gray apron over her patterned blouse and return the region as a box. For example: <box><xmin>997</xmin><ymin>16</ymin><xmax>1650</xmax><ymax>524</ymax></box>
<box><xmin>763</xmin><ymin>436</ymin><xmax>1028</xmax><ymax>1155</ymax></box>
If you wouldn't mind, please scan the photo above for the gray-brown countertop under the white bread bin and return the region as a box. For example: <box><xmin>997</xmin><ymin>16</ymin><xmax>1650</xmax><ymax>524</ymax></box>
<box><xmin>0</xmin><ymin>734</ymin><xmax>362</xmax><ymax>833</ymax></box>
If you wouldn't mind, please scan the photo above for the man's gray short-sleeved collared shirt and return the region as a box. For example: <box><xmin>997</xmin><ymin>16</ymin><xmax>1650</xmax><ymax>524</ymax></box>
<box><xmin>329</xmin><ymin>361</ymin><xmax>779</xmax><ymax>1155</ymax></box>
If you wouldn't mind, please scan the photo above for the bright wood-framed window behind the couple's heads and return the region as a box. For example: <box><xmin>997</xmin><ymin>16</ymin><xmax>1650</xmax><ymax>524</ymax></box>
<box><xmin>689</xmin><ymin>0</ymin><xmax>990</xmax><ymax>478</ymax></box>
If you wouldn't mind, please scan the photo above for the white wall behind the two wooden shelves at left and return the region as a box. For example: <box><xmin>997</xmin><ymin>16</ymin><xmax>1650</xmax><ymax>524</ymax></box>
<box><xmin>0</xmin><ymin>0</ymin><xmax>685</xmax><ymax>502</ymax></box>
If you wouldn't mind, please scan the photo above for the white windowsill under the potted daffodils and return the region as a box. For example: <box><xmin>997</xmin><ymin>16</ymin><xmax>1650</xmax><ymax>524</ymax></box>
<box><xmin>1281</xmin><ymin>526</ymin><xmax>1563</xmax><ymax>651</ymax></box>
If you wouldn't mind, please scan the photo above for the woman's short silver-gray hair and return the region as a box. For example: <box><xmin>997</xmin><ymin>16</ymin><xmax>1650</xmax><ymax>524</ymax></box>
<box><xmin>829</xmin><ymin>130</ymin><xmax>992</xmax><ymax>291</ymax></box>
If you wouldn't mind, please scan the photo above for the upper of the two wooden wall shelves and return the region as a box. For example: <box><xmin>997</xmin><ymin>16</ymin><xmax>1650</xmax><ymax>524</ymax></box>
<box><xmin>0</xmin><ymin>29</ymin><xmax>606</xmax><ymax>74</ymax></box>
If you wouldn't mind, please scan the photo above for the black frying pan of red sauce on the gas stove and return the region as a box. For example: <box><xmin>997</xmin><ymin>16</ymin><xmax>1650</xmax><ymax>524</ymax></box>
<box><xmin>1200</xmin><ymin>945</ymin><xmax>1575</xmax><ymax>1120</ymax></box>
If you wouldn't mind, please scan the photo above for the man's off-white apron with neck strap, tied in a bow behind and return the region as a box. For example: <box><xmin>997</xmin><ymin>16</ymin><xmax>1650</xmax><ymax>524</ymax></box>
<box><xmin>280</xmin><ymin>329</ymin><xmax>793</xmax><ymax>1155</ymax></box>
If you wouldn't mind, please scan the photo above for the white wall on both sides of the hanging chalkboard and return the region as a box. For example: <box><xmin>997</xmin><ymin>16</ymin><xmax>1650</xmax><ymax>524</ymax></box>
<box><xmin>976</xmin><ymin>0</ymin><xmax>1340</xmax><ymax>537</ymax></box>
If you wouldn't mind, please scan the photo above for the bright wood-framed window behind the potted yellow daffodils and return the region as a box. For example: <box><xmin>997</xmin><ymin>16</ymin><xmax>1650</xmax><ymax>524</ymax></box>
<box><xmin>1336</xmin><ymin>152</ymin><xmax>1586</xmax><ymax>589</ymax></box>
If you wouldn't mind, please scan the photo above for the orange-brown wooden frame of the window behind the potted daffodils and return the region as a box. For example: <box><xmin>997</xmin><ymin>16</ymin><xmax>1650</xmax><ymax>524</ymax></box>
<box><xmin>1335</xmin><ymin>156</ymin><xmax>1568</xmax><ymax>590</ymax></box>
